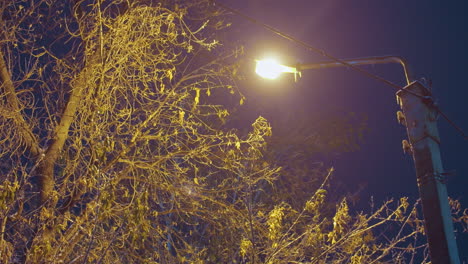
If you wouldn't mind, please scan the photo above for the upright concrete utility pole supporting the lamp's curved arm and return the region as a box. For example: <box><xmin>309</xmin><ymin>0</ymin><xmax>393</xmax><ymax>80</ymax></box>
<box><xmin>397</xmin><ymin>81</ymin><xmax>460</xmax><ymax>264</ymax></box>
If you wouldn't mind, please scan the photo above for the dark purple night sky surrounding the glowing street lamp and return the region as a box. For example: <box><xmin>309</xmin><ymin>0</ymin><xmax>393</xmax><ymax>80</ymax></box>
<box><xmin>222</xmin><ymin>0</ymin><xmax>468</xmax><ymax>261</ymax></box>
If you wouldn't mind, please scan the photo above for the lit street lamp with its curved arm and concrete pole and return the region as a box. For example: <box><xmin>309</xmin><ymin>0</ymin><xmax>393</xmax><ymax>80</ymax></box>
<box><xmin>256</xmin><ymin>56</ymin><xmax>460</xmax><ymax>264</ymax></box>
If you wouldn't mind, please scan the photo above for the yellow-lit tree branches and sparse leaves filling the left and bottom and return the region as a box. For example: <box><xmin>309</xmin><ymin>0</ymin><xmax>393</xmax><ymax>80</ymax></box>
<box><xmin>0</xmin><ymin>0</ymin><xmax>466</xmax><ymax>263</ymax></box>
